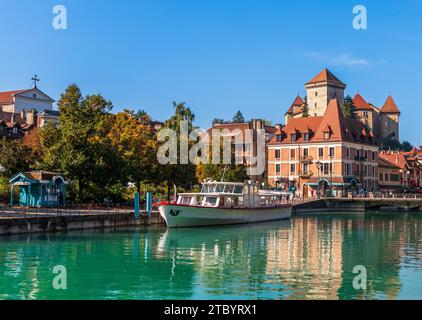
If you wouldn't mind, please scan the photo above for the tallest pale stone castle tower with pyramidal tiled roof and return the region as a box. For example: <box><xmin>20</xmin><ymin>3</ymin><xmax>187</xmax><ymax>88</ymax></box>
<box><xmin>305</xmin><ymin>69</ymin><xmax>346</xmax><ymax>117</ymax></box>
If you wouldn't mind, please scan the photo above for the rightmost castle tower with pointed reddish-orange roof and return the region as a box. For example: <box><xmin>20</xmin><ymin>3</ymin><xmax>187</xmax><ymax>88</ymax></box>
<box><xmin>380</xmin><ymin>95</ymin><xmax>400</xmax><ymax>141</ymax></box>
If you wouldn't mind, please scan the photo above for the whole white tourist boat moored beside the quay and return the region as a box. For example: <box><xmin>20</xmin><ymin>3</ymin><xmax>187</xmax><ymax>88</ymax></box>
<box><xmin>158</xmin><ymin>181</ymin><xmax>293</xmax><ymax>228</ymax></box>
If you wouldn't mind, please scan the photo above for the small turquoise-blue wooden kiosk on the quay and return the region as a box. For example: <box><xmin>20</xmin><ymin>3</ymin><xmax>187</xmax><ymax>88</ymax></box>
<box><xmin>10</xmin><ymin>171</ymin><xmax>68</xmax><ymax>208</ymax></box>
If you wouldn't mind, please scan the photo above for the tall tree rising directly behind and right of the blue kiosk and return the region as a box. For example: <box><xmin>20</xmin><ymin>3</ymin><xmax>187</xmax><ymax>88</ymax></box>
<box><xmin>41</xmin><ymin>84</ymin><xmax>119</xmax><ymax>202</ymax></box>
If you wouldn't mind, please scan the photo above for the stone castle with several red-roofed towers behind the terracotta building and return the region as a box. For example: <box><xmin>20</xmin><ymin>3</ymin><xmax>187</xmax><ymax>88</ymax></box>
<box><xmin>285</xmin><ymin>69</ymin><xmax>400</xmax><ymax>143</ymax></box>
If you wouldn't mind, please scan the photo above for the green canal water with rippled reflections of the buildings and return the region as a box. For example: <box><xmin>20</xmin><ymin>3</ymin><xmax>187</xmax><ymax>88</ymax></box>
<box><xmin>0</xmin><ymin>213</ymin><xmax>422</xmax><ymax>299</ymax></box>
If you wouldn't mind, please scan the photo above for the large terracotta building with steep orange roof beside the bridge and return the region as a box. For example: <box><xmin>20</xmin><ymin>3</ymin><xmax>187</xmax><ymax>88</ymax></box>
<box><xmin>268</xmin><ymin>98</ymin><xmax>378</xmax><ymax>197</ymax></box>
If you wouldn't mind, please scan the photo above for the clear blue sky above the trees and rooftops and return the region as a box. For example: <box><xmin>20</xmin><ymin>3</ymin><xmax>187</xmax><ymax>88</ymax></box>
<box><xmin>0</xmin><ymin>0</ymin><xmax>422</xmax><ymax>144</ymax></box>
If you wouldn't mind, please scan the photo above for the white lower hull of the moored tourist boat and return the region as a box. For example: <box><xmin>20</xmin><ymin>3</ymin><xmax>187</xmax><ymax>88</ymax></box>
<box><xmin>159</xmin><ymin>204</ymin><xmax>292</xmax><ymax>228</ymax></box>
